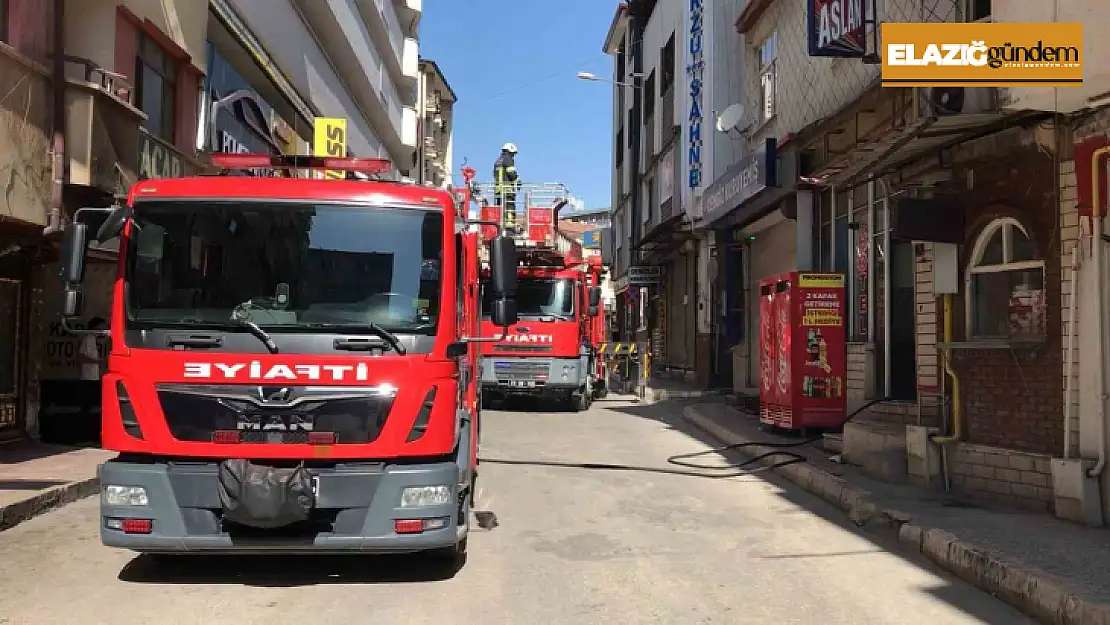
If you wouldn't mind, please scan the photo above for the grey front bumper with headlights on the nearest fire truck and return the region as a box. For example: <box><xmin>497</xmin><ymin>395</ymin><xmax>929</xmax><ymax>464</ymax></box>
<box><xmin>98</xmin><ymin>460</ymin><xmax>470</xmax><ymax>554</ymax></box>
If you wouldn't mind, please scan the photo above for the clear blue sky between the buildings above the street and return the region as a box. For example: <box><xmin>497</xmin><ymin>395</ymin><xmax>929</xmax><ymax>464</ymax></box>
<box><xmin>420</xmin><ymin>0</ymin><xmax>617</xmax><ymax>209</ymax></box>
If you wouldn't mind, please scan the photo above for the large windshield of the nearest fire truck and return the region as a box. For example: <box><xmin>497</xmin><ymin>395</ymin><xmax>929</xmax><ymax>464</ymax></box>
<box><xmin>127</xmin><ymin>200</ymin><xmax>444</xmax><ymax>335</ymax></box>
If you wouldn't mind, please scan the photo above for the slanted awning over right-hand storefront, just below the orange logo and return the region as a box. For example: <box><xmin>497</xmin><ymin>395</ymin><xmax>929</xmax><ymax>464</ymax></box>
<box><xmin>801</xmin><ymin>112</ymin><xmax>1036</xmax><ymax>187</ymax></box>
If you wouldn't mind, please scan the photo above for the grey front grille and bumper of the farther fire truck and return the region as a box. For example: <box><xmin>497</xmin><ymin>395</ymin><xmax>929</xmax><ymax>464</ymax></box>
<box><xmin>482</xmin><ymin>356</ymin><xmax>588</xmax><ymax>394</ymax></box>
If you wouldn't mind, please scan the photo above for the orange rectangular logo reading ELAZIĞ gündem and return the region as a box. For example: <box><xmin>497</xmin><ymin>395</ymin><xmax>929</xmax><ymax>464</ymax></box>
<box><xmin>882</xmin><ymin>22</ymin><xmax>1083</xmax><ymax>87</ymax></box>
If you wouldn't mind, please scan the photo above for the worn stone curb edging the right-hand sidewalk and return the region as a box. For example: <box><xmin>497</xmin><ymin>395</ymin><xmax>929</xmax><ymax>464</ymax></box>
<box><xmin>683</xmin><ymin>406</ymin><xmax>1110</xmax><ymax>625</ymax></box>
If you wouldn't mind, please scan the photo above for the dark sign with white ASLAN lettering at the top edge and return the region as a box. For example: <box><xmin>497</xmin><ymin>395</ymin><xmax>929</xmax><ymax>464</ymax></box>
<box><xmin>806</xmin><ymin>0</ymin><xmax>871</xmax><ymax>59</ymax></box>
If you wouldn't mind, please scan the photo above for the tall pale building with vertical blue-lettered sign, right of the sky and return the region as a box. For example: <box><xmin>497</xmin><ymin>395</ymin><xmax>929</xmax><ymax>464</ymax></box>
<box><xmin>604</xmin><ymin>0</ymin><xmax>713</xmax><ymax>385</ymax></box>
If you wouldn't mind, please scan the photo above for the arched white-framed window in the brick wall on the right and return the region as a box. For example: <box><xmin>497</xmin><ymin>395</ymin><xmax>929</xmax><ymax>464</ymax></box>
<box><xmin>965</xmin><ymin>218</ymin><xmax>1047</xmax><ymax>339</ymax></box>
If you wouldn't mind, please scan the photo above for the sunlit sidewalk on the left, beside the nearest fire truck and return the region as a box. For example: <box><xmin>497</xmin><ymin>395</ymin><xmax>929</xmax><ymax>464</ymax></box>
<box><xmin>0</xmin><ymin>441</ymin><xmax>115</xmax><ymax>532</ymax></box>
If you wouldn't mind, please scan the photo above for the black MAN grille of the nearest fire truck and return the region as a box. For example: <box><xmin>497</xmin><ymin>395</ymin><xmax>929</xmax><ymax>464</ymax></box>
<box><xmin>158</xmin><ymin>384</ymin><xmax>394</xmax><ymax>444</ymax></box>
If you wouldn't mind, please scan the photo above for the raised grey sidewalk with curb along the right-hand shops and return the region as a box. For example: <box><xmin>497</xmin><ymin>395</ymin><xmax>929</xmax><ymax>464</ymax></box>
<box><xmin>683</xmin><ymin>400</ymin><xmax>1110</xmax><ymax>625</ymax></box>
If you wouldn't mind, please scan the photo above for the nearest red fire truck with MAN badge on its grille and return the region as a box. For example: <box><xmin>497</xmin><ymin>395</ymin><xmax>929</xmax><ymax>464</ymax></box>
<box><xmin>53</xmin><ymin>154</ymin><xmax>517</xmax><ymax>558</ymax></box>
